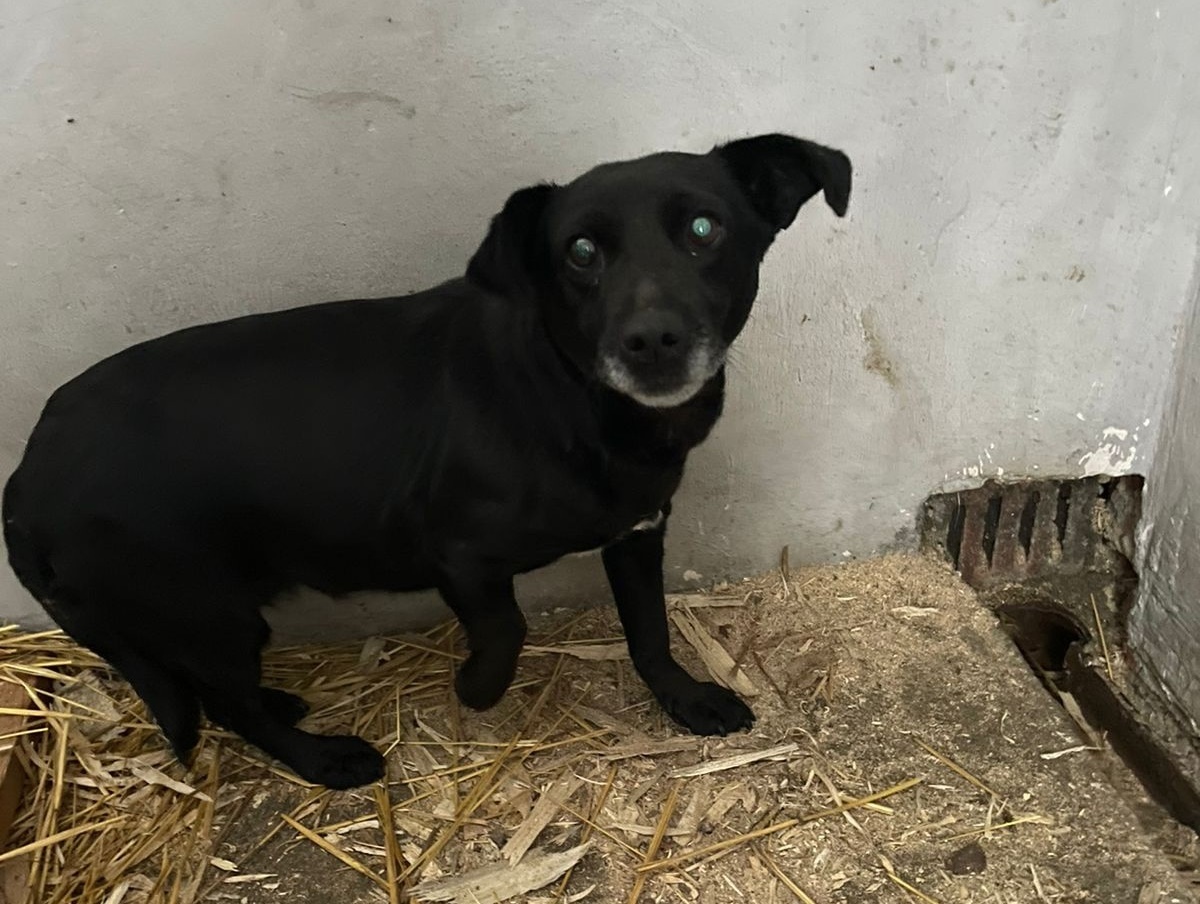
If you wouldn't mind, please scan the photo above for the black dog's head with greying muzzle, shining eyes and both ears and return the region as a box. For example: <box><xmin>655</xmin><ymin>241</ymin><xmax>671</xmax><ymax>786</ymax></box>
<box><xmin>467</xmin><ymin>134</ymin><xmax>851</xmax><ymax>408</ymax></box>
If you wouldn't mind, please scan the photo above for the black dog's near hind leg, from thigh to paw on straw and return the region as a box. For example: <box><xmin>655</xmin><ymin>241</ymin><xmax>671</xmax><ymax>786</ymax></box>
<box><xmin>47</xmin><ymin>522</ymin><xmax>383</xmax><ymax>788</ymax></box>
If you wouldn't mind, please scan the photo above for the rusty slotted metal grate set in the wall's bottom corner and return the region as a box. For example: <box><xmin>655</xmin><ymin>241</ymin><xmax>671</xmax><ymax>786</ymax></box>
<box><xmin>920</xmin><ymin>477</ymin><xmax>1142</xmax><ymax>587</ymax></box>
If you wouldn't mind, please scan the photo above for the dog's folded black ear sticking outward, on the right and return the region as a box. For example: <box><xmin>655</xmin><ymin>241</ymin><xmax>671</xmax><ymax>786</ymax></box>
<box><xmin>713</xmin><ymin>134</ymin><xmax>851</xmax><ymax>232</ymax></box>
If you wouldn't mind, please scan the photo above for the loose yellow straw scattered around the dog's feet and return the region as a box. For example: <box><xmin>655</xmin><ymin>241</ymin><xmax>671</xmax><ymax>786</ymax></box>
<box><xmin>0</xmin><ymin>558</ymin><xmax>1060</xmax><ymax>904</ymax></box>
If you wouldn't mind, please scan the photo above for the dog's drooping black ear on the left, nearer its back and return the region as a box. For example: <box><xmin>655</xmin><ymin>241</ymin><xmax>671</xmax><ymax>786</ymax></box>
<box><xmin>467</xmin><ymin>184</ymin><xmax>558</xmax><ymax>295</ymax></box>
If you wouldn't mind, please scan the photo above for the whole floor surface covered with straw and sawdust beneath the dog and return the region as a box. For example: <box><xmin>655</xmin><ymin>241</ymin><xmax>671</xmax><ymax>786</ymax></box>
<box><xmin>0</xmin><ymin>549</ymin><xmax>1196</xmax><ymax>904</ymax></box>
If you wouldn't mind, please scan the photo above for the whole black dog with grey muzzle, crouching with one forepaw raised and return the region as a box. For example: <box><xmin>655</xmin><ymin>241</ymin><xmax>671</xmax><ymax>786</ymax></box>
<box><xmin>4</xmin><ymin>134</ymin><xmax>851</xmax><ymax>788</ymax></box>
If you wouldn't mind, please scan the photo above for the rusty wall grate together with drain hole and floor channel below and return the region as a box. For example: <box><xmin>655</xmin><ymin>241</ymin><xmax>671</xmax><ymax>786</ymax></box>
<box><xmin>920</xmin><ymin>475</ymin><xmax>1200</xmax><ymax>831</ymax></box>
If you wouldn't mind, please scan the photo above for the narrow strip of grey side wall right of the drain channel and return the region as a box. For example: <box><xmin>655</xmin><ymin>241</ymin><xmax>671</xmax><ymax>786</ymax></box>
<box><xmin>1129</xmin><ymin>277</ymin><xmax>1200</xmax><ymax>726</ymax></box>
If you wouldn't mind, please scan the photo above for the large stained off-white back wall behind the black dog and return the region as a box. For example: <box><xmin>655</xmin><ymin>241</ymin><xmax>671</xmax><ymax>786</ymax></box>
<box><xmin>0</xmin><ymin>0</ymin><xmax>1200</xmax><ymax>627</ymax></box>
